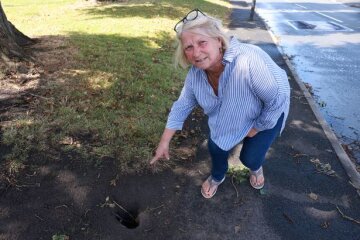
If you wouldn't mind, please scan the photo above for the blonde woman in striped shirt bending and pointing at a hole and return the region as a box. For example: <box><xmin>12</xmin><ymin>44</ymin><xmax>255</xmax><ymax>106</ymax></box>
<box><xmin>150</xmin><ymin>9</ymin><xmax>290</xmax><ymax>198</ymax></box>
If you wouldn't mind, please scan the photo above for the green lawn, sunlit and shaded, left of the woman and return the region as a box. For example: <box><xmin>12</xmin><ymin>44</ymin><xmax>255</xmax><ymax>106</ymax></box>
<box><xmin>2</xmin><ymin>0</ymin><xmax>229</xmax><ymax>172</ymax></box>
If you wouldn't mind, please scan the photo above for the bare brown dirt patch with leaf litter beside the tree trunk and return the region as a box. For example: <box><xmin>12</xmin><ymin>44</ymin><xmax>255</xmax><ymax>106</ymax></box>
<box><xmin>0</xmin><ymin>36</ymin><xmax>76</xmax><ymax>135</ymax></box>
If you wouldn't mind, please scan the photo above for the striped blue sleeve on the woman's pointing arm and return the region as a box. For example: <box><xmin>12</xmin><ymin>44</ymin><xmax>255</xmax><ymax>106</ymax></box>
<box><xmin>166</xmin><ymin>73</ymin><xmax>197</xmax><ymax>130</ymax></box>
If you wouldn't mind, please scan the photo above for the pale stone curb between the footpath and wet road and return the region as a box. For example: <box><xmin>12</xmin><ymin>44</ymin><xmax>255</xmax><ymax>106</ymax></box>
<box><xmin>262</xmin><ymin>16</ymin><xmax>360</xmax><ymax>190</ymax></box>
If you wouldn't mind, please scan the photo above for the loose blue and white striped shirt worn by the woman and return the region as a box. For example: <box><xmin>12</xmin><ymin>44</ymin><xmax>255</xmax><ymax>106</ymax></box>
<box><xmin>166</xmin><ymin>37</ymin><xmax>290</xmax><ymax>150</ymax></box>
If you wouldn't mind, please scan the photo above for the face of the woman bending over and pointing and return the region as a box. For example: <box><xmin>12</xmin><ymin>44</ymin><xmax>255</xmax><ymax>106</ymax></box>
<box><xmin>181</xmin><ymin>31</ymin><xmax>222</xmax><ymax>70</ymax></box>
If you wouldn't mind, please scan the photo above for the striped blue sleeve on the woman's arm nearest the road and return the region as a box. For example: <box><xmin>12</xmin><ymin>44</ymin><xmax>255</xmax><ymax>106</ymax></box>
<box><xmin>249</xmin><ymin>52</ymin><xmax>290</xmax><ymax>131</ymax></box>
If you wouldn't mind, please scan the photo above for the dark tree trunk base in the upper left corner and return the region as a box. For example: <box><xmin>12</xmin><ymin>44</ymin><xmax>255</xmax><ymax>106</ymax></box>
<box><xmin>0</xmin><ymin>2</ymin><xmax>34</xmax><ymax>60</ymax></box>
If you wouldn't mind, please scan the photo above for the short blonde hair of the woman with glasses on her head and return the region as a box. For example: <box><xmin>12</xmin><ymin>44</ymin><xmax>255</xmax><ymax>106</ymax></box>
<box><xmin>174</xmin><ymin>13</ymin><xmax>230</xmax><ymax>68</ymax></box>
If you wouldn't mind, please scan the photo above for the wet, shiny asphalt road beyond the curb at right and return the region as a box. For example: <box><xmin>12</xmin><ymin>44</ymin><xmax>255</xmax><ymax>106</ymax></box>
<box><xmin>256</xmin><ymin>0</ymin><xmax>360</xmax><ymax>163</ymax></box>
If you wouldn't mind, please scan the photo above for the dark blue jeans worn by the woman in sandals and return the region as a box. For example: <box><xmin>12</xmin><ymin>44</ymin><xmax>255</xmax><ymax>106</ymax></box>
<box><xmin>208</xmin><ymin>114</ymin><xmax>284</xmax><ymax>181</ymax></box>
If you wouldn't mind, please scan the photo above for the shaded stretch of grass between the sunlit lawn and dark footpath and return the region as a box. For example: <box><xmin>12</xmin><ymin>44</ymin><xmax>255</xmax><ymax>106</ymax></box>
<box><xmin>0</xmin><ymin>27</ymin><xmax>188</xmax><ymax>184</ymax></box>
